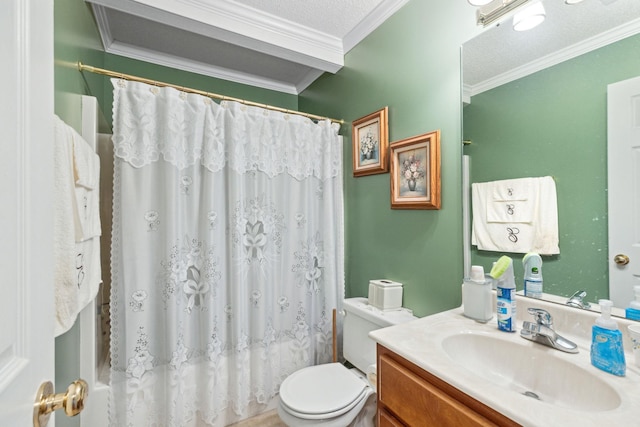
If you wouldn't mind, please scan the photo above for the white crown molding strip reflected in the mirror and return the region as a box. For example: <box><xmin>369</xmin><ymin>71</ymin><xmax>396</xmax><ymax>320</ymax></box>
<box><xmin>468</xmin><ymin>19</ymin><xmax>640</xmax><ymax>97</ymax></box>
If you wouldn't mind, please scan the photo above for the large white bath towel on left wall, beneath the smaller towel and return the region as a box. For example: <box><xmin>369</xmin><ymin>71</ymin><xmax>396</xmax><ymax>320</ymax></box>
<box><xmin>53</xmin><ymin>116</ymin><xmax>101</xmax><ymax>336</ymax></box>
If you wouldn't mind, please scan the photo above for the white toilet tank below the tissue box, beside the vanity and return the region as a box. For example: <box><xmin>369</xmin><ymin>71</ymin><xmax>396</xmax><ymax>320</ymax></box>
<box><xmin>342</xmin><ymin>298</ymin><xmax>417</xmax><ymax>372</ymax></box>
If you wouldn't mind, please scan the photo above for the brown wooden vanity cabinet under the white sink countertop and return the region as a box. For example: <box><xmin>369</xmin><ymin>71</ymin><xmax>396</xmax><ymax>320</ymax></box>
<box><xmin>377</xmin><ymin>344</ymin><xmax>519</xmax><ymax>427</ymax></box>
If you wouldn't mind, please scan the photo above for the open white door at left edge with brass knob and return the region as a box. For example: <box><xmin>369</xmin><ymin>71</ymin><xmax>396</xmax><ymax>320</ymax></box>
<box><xmin>0</xmin><ymin>0</ymin><xmax>54</xmax><ymax>427</ymax></box>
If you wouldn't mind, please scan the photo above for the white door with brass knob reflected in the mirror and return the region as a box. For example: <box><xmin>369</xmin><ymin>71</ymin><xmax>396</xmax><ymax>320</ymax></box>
<box><xmin>607</xmin><ymin>77</ymin><xmax>640</xmax><ymax>307</ymax></box>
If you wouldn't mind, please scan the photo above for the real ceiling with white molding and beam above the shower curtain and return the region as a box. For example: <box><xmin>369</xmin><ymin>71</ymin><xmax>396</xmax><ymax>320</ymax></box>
<box><xmin>85</xmin><ymin>0</ymin><xmax>408</xmax><ymax>94</ymax></box>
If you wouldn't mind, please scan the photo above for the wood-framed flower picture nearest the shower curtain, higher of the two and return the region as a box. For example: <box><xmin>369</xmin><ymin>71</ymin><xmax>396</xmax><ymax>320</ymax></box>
<box><xmin>351</xmin><ymin>107</ymin><xmax>389</xmax><ymax>176</ymax></box>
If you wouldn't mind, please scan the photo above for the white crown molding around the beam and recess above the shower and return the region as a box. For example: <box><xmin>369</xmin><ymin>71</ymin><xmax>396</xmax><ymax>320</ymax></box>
<box><xmin>84</xmin><ymin>0</ymin><xmax>409</xmax><ymax>94</ymax></box>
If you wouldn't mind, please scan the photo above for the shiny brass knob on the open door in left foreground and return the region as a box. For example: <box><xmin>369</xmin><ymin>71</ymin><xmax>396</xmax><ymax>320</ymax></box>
<box><xmin>33</xmin><ymin>379</ymin><xmax>89</xmax><ymax>427</ymax></box>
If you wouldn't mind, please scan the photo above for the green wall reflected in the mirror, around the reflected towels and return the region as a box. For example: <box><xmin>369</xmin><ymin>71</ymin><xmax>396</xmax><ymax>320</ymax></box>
<box><xmin>464</xmin><ymin>36</ymin><xmax>640</xmax><ymax>301</ymax></box>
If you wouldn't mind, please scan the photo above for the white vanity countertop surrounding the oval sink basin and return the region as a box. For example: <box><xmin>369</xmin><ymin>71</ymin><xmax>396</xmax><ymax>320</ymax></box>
<box><xmin>369</xmin><ymin>297</ymin><xmax>640</xmax><ymax>427</ymax></box>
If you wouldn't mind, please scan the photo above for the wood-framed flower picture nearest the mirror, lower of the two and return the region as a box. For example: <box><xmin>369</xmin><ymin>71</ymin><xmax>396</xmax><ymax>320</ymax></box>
<box><xmin>391</xmin><ymin>130</ymin><xmax>440</xmax><ymax>209</ymax></box>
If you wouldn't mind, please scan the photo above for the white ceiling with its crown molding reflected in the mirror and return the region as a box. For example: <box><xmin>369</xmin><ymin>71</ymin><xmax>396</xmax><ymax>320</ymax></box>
<box><xmin>463</xmin><ymin>0</ymin><xmax>640</xmax><ymax>95</ymax></box>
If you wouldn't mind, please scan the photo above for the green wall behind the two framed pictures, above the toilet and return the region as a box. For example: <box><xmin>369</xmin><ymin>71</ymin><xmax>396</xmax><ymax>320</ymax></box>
<box><xmin>299</xmin><ymin>1</ymin><xmax>478</xmax><ymax>316</ymax></box>
